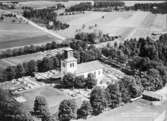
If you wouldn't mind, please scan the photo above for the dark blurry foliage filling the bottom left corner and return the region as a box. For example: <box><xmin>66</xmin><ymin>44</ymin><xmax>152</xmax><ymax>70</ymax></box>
<box><xmin>0</xmin><ymin>89</ymin><xmax>33</xmax><ymax>121</ymax></box>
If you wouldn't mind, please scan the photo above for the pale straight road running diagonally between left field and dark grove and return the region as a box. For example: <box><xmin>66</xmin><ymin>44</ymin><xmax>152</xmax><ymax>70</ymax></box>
<box><xmin>16</xmin><ymin>14</ymin><xmax>66</xmax><ymax>40</ymax></box>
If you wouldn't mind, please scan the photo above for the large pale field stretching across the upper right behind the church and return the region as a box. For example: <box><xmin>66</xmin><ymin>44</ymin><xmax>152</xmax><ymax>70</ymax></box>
<box><xmin>58</xmin><ymin>11</ymin><xmax>167</xmax><ymax>39</ymax></box>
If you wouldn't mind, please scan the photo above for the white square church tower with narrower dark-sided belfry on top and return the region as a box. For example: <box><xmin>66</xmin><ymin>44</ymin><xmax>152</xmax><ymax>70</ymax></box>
<box><xmin>61</xmin><ymin>48</ymin><xmax>77</xmax><ymax>74</ymax></box>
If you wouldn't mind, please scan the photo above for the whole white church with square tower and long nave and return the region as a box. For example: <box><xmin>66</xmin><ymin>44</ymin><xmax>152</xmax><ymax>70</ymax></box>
<box><xmin>61</xmin><ymin>48</ymin><xmax>104</xmax><ymax>84</ymax></box>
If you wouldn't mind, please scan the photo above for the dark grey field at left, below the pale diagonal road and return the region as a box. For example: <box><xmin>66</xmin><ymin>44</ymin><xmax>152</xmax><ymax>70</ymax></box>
<box><xmin>0</xmin><ymin>22</ymin><xmax>60</xmax><ymax>50</ymax></box>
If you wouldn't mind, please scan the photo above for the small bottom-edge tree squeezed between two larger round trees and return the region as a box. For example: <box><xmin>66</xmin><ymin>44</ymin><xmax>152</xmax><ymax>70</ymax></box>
<box><xmin>77</xmin><ymin>101</ymin><xmax>92</xmax><ymax>119</ymax></box>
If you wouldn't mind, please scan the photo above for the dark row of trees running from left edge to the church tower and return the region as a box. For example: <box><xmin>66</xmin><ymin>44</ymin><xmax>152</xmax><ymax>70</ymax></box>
<box><xmin>0</xmin><ymin>54</ymin><xmax>63</xmax><ymax>82</ymax></box>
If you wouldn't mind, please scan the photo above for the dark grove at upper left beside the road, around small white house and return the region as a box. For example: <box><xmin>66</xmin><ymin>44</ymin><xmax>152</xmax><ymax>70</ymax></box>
<box><xmin>23</xmin><ymin>8</ymin><xmax>69</xmax><ymax>30</ymax></box>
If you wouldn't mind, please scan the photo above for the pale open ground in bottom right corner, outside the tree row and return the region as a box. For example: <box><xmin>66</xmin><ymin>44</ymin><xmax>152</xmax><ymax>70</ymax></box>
<box><xmin>75</xmin><ymin>99</ymin><xmax>167</xmax><ymax>121</ymax></box>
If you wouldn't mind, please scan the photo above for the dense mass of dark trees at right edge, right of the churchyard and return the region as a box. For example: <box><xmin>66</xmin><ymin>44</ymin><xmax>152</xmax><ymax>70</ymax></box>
<box><xmin>102</xmin><ymin>34</ymin><xmax>167</xmax><ymax>91</ymax></box>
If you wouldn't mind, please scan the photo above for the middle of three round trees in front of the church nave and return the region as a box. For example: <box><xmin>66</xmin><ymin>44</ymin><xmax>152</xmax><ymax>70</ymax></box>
<box><xmin>75</xmin><ymin>76</ymin><xmax>86</xmax><ymax>88</ymax></box>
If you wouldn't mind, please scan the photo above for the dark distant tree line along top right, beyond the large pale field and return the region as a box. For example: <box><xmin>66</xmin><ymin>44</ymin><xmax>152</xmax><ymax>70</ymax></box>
<box><xmin>66</xmin><ymin>1</ymin><xmax>167</xmax><ymax>14</ymax></box>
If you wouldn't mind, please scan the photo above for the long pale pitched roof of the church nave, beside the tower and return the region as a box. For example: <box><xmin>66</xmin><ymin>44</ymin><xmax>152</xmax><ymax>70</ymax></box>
<box><xmin>76</xmin><ymin>60</ymin><xmax>104</xmax><ymax>74</ymax></box>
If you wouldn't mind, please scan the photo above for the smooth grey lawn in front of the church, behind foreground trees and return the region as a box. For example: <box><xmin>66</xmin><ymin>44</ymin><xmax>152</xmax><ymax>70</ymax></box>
<box><xmin>21</xmin><ymin>87</ymin><xmax>70</xmax><ymax>114</ymax></box>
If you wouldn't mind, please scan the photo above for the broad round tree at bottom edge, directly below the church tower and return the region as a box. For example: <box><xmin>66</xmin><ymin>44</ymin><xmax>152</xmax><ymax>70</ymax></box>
<box><xmin>58</xmin><ymin>100</ymin><xmax>77</xmax><ymax>121</ymax></box>
